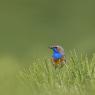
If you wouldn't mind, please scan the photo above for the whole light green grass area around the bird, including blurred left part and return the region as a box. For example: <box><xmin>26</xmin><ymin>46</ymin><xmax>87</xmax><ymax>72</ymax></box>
<box><xmin>0</xmin><ymin>52</ymin><xmax>95</xmax><ymax>95</ymax></box>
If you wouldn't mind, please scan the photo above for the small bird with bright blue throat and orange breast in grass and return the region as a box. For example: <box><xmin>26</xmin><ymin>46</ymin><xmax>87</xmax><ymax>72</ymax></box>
<box><xmin>49</xmin><ymin>45</ymin><xmax>66</xmax><ymax>66</ymax></box>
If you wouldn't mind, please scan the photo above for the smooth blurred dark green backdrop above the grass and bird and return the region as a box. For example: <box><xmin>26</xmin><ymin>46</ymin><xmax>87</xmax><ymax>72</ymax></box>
<box><xmin>0</xmin><ymin>0</ymin><xmax>95</xmax><ymax>56</ymax></box>
